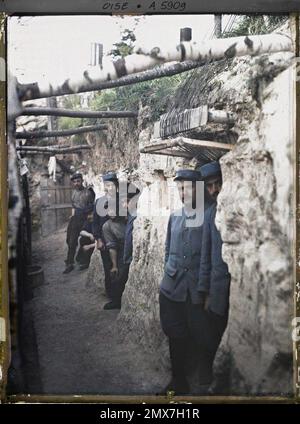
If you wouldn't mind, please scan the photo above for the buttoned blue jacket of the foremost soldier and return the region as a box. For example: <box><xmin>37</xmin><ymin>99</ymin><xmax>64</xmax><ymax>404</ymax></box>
<box><xmin>160</xmin><ymin>209</ymin><xmax>203</xmax><ymax>303</ymax></box>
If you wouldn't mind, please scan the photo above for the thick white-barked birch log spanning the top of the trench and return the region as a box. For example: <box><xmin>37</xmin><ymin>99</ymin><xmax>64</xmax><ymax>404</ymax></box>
<box><xmin>17</xmin><ymin>33</ymin><xmax>293</xmax><ymax>100</ymax></box>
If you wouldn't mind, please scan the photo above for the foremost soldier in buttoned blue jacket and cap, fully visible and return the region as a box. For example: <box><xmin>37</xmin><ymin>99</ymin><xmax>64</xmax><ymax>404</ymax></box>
<box><xmin>159</xmin><ymin>170</ymin><xmax>209</xmax><ymax>394</ymax></box>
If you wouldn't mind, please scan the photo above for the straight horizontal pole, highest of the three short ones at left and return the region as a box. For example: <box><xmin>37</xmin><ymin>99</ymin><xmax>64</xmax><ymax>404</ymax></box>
<box><xmin>21</xmin><ymin>107</ymin><xmax>138</xmax><ymax>118</ymax></box>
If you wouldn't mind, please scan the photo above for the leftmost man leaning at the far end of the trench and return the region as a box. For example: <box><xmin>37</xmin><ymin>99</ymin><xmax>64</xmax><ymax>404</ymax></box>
<box><xmin>63</xmin><ymin>172</ymin><xmax>94</xmax><ymax>274</ymax></box>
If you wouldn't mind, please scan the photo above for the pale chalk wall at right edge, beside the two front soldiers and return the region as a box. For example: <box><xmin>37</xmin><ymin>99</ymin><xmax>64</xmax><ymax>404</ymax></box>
<box><xmin>216</xmin><ymin>69</ymin><xmax>294</xmax><ymax>394</ymax></box>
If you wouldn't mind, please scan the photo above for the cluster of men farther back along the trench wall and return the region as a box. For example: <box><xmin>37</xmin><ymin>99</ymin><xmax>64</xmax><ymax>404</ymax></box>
<box><xmin>64</xmin><ymin>172</ymin><xmax>139</xmax><ymax>309</ymax></box>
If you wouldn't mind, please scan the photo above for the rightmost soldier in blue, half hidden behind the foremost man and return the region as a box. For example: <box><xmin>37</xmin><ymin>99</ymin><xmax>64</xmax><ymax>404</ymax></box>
<box><xmin>198</xmin><ymin>162</ymin><xmax>230</xmax><ymax>388</ymax></box>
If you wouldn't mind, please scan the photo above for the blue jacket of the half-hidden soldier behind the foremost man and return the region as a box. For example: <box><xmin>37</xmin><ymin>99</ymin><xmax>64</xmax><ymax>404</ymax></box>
<box><xmin>198</xmin><ymin>203</ymin><xmax>230</xmax><ymax>315</ymax></box>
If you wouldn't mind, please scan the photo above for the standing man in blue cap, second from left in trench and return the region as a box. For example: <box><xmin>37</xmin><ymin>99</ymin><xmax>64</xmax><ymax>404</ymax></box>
<box><xmin>93</xmin><ymin>172</ymin><xmax>119</xmax><ymax>300</ymax></box>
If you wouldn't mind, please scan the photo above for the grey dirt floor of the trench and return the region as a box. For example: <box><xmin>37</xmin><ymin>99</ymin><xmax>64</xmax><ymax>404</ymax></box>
<box><xmin>32</xmin><ymin>229</ymin><xmax>168</xmax><ymax>395</ymax></box>
